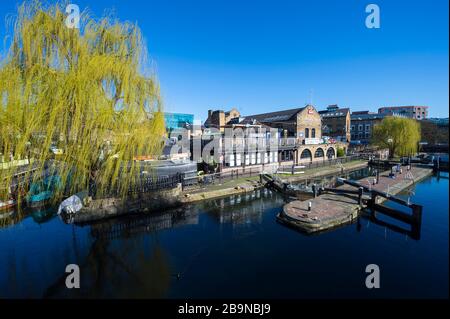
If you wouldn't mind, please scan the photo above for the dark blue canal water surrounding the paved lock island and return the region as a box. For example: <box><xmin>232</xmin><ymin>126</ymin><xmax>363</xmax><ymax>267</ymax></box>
<box><xmin>0</xmin><ymin>173</ymin><xmax>449</xmax><ymax>298</ymax></box>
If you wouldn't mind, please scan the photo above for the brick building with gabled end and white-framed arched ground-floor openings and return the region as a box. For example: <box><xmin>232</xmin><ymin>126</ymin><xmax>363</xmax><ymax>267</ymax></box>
<box><xmin>200</xmin><ymin>105</ymin><xmax>347</xmax><ymax>170</ymax></box>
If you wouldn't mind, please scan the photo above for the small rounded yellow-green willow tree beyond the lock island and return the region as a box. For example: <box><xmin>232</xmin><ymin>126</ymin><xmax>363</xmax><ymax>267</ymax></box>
<box><xmin>372</xmin><ymin>116</ymin><xmax>420</xmax><ymax>158</ymax></box>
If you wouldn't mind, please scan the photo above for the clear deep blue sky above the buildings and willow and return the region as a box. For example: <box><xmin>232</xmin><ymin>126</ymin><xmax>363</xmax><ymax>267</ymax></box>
<box><xmin>0</xmin><ymin>0</ymin><xmax>449</xmax><ymax>120</ymax></box>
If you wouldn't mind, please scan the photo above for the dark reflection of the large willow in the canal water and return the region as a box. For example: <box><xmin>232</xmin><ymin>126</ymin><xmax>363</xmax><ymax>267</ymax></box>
<box><xmin>43</xmin><ymin>231</ymin><xmax>172</xmax><ymax>298</ymax></box>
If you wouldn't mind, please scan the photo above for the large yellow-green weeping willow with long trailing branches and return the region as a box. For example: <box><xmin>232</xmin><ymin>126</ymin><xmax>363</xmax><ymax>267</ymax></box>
<box><xmin>0</xmin><ymin>1</ymin><xmax>165</xmax><ymax>205</ymax></box>
